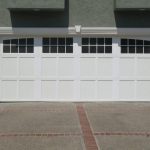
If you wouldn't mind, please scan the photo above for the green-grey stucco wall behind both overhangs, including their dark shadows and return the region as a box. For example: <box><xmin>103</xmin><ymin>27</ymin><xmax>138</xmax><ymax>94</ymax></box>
<box><xmin>0</xmin><ymin>0</ymin><xmax>150</xmax><ymax>27</ymax></box>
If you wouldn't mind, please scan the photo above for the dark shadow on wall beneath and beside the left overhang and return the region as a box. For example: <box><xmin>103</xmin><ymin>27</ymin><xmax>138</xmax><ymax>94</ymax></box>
<box><xmin>10</xmin><ymin>0</ymin><xmax>69</xmax><ymax>27</ymax></box>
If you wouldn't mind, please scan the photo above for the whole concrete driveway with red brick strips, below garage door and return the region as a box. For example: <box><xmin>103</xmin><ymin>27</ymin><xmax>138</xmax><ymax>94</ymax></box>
<box><xmin>0</xmin><ymin>102</ymin><xmax>150</xmax><ymax>150</ymax></box>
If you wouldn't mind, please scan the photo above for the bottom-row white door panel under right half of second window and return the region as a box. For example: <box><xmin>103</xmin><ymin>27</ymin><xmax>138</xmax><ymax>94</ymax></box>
<box><xmin>58</xmin><ymin>81</ymin><xmax>74</xmax><ymax>100</ymax></box>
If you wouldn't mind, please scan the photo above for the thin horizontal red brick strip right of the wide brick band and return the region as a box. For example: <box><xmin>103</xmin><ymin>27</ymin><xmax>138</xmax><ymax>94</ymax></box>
<box><xmin>94</xmin><ymin>132</ymin><xmax>150</xmax><ymax>137</ymax></box>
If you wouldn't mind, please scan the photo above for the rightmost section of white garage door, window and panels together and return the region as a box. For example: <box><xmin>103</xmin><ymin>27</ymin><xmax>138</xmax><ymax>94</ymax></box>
<box><xmin>119</xmin><ymin>39</ymin><xmax>150</xmax><ymax>100</ymax></box>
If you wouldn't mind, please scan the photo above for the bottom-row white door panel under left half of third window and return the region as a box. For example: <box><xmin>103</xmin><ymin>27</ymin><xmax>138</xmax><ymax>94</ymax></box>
<box><xmin>80</xmin><ymin>81</ymin><xmax>96</xmax><ymax>100</ymax></box>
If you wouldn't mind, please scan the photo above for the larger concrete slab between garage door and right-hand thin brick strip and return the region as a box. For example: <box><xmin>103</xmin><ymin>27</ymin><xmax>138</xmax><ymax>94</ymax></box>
<box><xmin>84</xmin><ymin>102</ymin><xmax>150</xmax><ymax>132</ymax></box>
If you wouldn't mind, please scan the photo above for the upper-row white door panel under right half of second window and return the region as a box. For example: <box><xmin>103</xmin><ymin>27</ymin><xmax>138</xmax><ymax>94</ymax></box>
<box><xmin>58</xmin><ymin>58</ymin><xmax>74</xmax><ymax>77</ymax></box>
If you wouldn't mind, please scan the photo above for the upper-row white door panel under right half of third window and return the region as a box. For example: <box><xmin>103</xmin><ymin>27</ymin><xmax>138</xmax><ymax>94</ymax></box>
<box><xmin>97</xmin><ymin>58</ymin><xmax>113</xmax><ymax>77</ymax></box>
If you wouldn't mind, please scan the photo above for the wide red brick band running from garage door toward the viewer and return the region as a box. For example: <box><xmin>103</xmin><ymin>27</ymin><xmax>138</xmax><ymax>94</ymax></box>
<box><xmin>76</xmin><ymin>104</ymin><xmax>98</xmax><ymax>150</ymax></box>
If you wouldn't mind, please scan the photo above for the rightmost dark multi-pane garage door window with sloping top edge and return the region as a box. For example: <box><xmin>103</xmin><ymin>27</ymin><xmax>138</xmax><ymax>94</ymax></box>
<box><xmin>121</xmin><ymin>39</ymin><xmax>150</xmax><ymax>54</ymax></box>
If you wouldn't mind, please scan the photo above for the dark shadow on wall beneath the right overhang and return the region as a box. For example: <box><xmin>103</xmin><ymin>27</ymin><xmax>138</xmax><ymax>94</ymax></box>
<box><xmin>115</xmin><ymin>11</ymin><xmax>150</xmax><ymax>28</ymax></box>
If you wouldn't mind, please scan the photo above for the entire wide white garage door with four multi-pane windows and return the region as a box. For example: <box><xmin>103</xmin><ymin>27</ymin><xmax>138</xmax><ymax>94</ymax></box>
<box><xmin>0</xmin><ymin>37</ymin><xmax>150</xmax><ymax>101</ymax></box>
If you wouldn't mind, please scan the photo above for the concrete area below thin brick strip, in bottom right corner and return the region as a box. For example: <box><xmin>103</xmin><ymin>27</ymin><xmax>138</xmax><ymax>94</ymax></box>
<box><xmin>96</xmin><ymin>136</ymin><xmax>150</xmax><ymax>150</ymax></box>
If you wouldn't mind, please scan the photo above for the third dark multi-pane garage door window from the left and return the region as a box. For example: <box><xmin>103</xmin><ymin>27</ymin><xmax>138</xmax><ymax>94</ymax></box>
<box><xmin>82</xmin><ymin>38</ymin><xmax>112</xmax><ymax>53</ymax></box>
